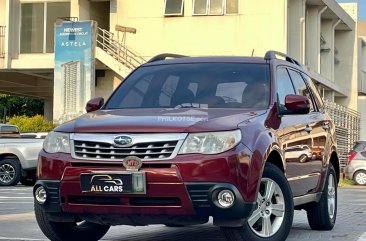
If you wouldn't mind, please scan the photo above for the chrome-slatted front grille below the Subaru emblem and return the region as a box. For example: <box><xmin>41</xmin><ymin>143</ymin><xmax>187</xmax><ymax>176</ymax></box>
<box><xmin>74</xmin><ymin>141</ymin><xmax>178</xmax><ymax>160</ymax></box>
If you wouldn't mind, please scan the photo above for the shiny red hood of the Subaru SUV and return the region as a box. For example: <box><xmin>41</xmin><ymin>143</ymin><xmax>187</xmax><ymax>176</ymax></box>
<box><xmin>55</xmin><ymin>108</ymin><xmax>266</xmax><ymax>133</ymax></box>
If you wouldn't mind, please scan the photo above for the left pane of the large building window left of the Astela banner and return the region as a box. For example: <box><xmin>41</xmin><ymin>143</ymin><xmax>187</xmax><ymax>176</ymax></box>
<box><xmin>20</xmin><ymin>3</ymin><xmax>44</xmax><ymax>53</ymax></box>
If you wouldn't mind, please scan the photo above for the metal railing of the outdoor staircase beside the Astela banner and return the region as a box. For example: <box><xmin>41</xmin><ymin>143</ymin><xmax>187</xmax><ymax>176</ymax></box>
<box><xmin>97</xmin><ymin>28</ymin><xmax>146</xmax><ymax>70</ymax></box>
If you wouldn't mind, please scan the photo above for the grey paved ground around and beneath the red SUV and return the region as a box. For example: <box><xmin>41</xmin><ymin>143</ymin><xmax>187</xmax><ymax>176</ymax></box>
<box><xmin>0</xmin><ymin>186</ymin><xmax>366</xmax><ymax>241</ymax></box>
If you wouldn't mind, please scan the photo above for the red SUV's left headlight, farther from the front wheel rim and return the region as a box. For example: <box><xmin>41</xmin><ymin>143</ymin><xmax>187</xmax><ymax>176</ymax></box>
<box><xmin>43</xmin><ymin>131</ymin><xmax>70</xmax><ymax>153</ymax></box>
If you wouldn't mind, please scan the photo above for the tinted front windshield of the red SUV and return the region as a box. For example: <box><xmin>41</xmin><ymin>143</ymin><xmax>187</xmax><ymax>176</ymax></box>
<box><xmin>105</xmin><ymin>63</ymin><xmax>269</xmax><ymax>109</ymax></box>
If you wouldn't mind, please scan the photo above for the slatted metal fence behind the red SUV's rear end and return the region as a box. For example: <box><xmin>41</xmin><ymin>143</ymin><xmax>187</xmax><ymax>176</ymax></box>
<box><xmin>325</xmin><ymin>101</ymin><xmax>361</xmax><ymax>167</ymax></box>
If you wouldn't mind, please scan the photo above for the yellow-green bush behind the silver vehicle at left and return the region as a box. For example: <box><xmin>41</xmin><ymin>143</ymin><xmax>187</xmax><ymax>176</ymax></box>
<box><xmin>8</xmin><ymin>115</ymin><xmax>55</xmax><ymax>132</ymax></box>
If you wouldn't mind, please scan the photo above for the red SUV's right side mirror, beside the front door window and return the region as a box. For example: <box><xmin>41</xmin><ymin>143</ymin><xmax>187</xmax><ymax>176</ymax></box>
<box><xmin>279</xmin><ymin>95</ymin><xmax>310</xmax><ymax>115</ymax></box>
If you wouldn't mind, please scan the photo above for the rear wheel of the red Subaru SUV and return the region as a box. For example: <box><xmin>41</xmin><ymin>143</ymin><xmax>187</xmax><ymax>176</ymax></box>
<box><xmin>306</xmin><ymin>164</ymin><xmax>337</xmax><ymax>230</ymax></box>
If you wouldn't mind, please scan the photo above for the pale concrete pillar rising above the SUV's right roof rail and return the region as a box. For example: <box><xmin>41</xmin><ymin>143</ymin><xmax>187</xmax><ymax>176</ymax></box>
<box><xmin>287</xmin><ymin>0</ymin><xmax>305</xmax><ymax>64</ymax></box>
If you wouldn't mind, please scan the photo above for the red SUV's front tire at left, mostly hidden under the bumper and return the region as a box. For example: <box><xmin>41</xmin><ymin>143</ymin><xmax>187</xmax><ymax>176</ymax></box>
<box><xmin>34</xmin><ymin>200</ymin><xmax>110</xmax><ymax>241</ymax></box>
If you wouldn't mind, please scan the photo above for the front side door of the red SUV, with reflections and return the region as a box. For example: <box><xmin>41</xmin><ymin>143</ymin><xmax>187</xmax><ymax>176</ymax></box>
<box><xmin>276</xmin><ymin>67</ymin><xmax>316</xmax><ymax>196</ymax></box>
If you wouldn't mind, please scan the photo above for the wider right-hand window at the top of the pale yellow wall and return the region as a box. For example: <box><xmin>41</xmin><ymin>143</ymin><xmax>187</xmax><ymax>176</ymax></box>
<box><xmin>193</xmin><ymin>0</ymin><xmax>239</xmax><ymax>15</ymax></box>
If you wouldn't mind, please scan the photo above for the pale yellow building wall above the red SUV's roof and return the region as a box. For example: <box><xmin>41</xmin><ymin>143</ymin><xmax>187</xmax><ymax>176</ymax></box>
<box><xmin>116</xmin><ymin>0</ymin><xmax>287</xmax><ymax>58</ymax></box>
